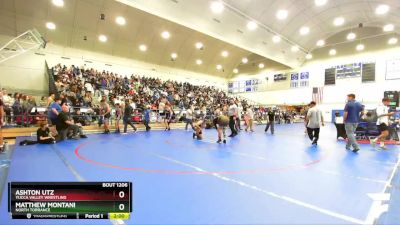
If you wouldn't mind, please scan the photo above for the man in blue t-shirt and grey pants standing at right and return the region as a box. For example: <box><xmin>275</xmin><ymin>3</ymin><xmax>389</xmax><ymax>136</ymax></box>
<box><xmin>343</xmin><ymin>94</ymin><xmax>363</xmax><ymax>153</ymax></box>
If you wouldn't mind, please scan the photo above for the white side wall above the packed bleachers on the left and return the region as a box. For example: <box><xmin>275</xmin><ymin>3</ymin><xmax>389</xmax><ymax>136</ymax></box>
<box><xmin>0</xmin><ymin>35</ymin><xmax>227</xmax><ymax>94</ymax></box>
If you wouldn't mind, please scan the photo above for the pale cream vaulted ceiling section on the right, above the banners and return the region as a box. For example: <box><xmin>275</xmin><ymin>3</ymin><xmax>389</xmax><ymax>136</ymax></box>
<box><xmin>117</xmin><ymin>0</ymin><xmax>400</xmax><ymax>68</ymax></box>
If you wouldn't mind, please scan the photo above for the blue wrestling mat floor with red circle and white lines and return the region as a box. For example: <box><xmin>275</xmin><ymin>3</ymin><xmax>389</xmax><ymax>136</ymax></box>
<box><xmin>0</xmin><ymin>124</ymin><xmax>400</xmax><ymax>224</ymax></box>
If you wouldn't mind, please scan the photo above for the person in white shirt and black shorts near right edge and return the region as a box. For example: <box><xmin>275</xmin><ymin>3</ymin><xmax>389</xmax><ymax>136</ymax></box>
<box><xmin>371</xmin><ymin>98</ymin><xmax>394</xmax><ymax>150</ymax></box>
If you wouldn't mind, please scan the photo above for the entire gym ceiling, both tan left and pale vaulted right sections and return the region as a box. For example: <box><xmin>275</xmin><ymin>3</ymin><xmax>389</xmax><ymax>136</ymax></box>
<box><xmin>0</xmin><ymin>0</ymin><xmax>400</xmax><ymax>78</ymax></box>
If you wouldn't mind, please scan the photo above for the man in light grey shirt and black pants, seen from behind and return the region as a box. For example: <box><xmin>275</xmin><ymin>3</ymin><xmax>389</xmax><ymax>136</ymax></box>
<box><xmin>306</xmin><ymin>101</ymin><xmax>325</xmax><ymax>145</ymax></box>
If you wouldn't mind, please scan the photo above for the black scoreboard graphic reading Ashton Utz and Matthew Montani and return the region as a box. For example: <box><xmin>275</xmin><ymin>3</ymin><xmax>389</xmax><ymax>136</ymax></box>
<box><xmin>8</xmin><ymin>182</ymin><xmax>132</xmax><ymax>219</ymax></box>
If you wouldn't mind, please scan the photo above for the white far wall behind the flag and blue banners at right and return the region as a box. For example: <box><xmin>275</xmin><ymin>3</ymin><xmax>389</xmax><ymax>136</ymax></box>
<box><xmin>232</xmin><ymin>47</ymin><xmax>400</xmax><ymax>119</ymax></box>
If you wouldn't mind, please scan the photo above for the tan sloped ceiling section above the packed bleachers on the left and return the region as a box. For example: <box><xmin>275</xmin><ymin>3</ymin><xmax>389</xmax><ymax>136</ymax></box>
<box><xmin>0</xmin><ymin>0</ymin><xmax>287</xmax><ymax>78</ymax></box>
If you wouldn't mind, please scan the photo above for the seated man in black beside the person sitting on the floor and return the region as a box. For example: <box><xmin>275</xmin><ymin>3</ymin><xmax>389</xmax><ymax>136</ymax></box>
<box><xmin>56</xmin><ymin>104</ymin><xmax>87</xmax><ymax>141</ymax></box>
